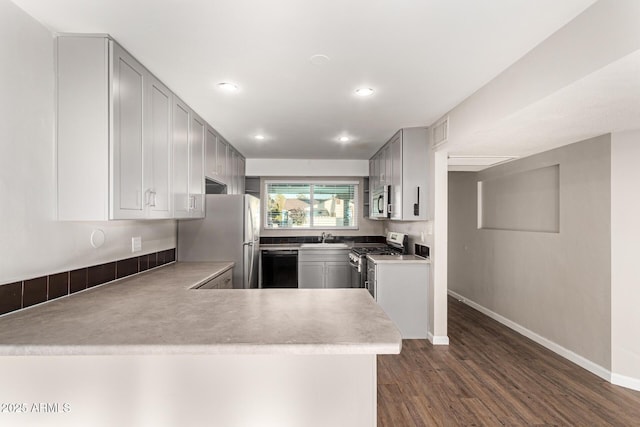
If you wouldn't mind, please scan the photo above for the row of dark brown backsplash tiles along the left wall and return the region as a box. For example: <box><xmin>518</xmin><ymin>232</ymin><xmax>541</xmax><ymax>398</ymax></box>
<box><xmin>0</xmin><ymin>249</ymin><xmax>176</xmax><ymax>315</ymax></box>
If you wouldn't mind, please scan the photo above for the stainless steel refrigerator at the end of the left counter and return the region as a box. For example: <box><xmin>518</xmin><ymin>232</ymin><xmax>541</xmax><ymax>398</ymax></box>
<box><xmin>178</xmin><ymin>194</ymin><xmax>260</xmax><ymax>288</ymax></box>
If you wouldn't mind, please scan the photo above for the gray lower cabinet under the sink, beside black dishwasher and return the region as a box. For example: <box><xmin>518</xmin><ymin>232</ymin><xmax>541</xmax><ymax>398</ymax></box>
<box><xmin>298</xmin><ymin>249</ymin><xmax>351</xmax><ymax>289</ymax></box>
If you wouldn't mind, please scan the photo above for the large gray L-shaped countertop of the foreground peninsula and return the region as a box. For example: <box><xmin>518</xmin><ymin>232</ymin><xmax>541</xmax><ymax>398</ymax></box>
<box><xmin>0</xmin><ymin>263</ymin><xmax>402</xmax><ymax>355</ymax></box>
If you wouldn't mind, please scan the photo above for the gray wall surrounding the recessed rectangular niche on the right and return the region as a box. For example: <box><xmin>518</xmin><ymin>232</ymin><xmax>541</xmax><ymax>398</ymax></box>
<box><xmin>448</xmin><ymin>135</ymin><xmax>611</xmax><ymax>369</ymax></box>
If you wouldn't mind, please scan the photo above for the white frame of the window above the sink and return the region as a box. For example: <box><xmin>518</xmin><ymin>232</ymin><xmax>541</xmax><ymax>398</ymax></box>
<box><xmin>262</xmin><ymin>179</ymin><xmax>360</xmax><ymax>230</ymax></box>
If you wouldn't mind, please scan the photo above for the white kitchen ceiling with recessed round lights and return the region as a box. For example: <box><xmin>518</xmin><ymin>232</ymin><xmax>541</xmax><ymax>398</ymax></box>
<box><xmin>13</xmin><ymin>0</ymin><xmax>594</xmax><ymax>159</ymax></box>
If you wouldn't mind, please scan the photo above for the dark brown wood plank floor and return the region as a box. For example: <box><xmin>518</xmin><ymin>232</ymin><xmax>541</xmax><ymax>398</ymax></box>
<box><xmin>378</xmin><ymin>298</ymin><xmax>640</xmax><ymax>427</ymax></box>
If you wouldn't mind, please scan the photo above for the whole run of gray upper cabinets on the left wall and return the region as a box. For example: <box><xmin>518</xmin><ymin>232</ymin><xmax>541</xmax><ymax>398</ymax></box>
<box><xmin>56</xmin><ymin>34</ymin><xmax>244</xmax><ymax>221</ymax></box>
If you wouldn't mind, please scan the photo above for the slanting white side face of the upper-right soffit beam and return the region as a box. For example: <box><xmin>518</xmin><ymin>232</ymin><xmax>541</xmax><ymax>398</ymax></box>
<box><xmin>446</xmin><ymin>0</ymin><xmax>640</xmax><ymax>154</ymax></box>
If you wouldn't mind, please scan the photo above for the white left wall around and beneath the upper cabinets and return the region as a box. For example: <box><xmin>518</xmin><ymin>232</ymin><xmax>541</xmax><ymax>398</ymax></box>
<box><xmin>0</xmin><ymin>0</ymin><xmax>176</xmax><ymax>284</ymax></box>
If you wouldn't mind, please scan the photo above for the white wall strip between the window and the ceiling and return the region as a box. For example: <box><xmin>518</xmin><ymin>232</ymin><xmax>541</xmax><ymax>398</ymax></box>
<box><xmin>246</xmin><ymin>159</ymin><xmax>369</xmax><ymax>176</ymax></box>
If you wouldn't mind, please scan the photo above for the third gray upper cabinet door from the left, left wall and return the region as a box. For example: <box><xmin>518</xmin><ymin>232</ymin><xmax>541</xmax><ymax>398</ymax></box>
<box><xmin>172</xmin><ymin>97</ymin><xmax>190</xmax><ymax>218</ymax></box>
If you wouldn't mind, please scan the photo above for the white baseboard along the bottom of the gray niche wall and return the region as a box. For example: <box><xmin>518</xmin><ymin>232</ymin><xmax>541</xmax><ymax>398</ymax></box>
<box><xmin>447</xmin><ymin>290</ymin><xmax>612</xmax><ymax>387</ymax></box>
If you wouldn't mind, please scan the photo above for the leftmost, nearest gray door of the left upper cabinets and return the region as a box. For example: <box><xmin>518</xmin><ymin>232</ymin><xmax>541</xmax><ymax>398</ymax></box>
<box><xmin>110</xmin><ymin>43</ymin><xmax>145</xmax><ymax>219</ymax></box>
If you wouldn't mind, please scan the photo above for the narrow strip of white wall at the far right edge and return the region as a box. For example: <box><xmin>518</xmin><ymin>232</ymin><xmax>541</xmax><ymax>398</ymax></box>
<box><xmin>611</xmin><ymin>130</ymin><xmax>640</xmax><ymax>390</ymax></box>
